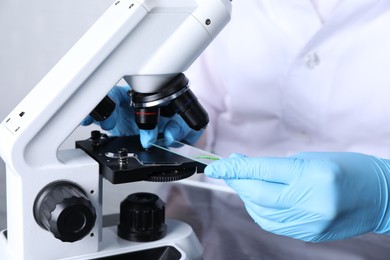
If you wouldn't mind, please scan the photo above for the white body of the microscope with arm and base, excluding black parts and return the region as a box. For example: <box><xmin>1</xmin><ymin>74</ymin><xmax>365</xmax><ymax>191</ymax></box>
<box><xmin>0</xmin><ymin>0</ymin><xmax>231</xmax><ymax>260</ymax></box>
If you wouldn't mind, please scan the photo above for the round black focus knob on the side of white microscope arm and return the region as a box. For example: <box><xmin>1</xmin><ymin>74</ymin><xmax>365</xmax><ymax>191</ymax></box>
<box><xmin>34</xmin><ymin>181</ymin><xmax>96</xmax><ymax>242</ymax></box>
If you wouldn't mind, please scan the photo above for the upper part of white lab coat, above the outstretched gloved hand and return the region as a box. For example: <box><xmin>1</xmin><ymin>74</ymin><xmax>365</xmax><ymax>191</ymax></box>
<box><xmin>186</xmin><ymin>0</ymin><xmax>390</xmax><ymax>158</ymax></box>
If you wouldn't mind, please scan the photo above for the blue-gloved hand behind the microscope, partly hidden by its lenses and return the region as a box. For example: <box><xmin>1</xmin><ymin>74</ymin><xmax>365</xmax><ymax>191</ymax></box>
<box><xmin>81</xmin><ymin>86</ymin><xmax>202</xmax><ymax>148</ymax></box>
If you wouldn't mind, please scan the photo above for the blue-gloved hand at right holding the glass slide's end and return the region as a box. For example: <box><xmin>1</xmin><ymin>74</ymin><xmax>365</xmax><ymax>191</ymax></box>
<box><xmin>205</xmin><ymin>152</ymin><xmax>390</xmax><ymax>242</ymax></box>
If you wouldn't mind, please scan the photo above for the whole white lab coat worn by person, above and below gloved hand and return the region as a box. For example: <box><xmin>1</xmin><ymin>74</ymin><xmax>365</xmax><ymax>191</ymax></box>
<box><xmin>173</xmin><ymin>0</ymin><xmax>390</xmax><ymax>260</ymax></box>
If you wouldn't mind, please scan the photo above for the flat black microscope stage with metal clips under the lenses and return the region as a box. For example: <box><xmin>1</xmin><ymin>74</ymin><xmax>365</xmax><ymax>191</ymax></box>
<box><xmin>76</xmin><ymin>134</ymin><xmax>206</xmax><ymax>184</ymax></box>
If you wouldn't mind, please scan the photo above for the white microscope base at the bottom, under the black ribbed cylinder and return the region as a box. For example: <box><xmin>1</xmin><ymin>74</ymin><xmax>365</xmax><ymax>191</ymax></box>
<box><xmin>0</xmin><ymin>219</ymin><xmax>203</xmax><ymax>260</ymax></box>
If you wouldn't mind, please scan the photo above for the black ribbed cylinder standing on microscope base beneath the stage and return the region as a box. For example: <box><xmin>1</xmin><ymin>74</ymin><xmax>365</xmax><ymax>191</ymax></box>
<box><xmin>118</xmin><ymin>192</ymin><xmax>167</xmax><ymax>242</ymax></box>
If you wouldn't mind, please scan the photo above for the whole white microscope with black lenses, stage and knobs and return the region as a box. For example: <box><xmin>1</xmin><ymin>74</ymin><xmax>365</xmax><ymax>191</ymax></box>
<box><xmin>0</xmin><ymin>0</ymin><xmax>231</xmax><ymax>260</ymax></box>
